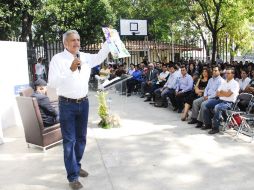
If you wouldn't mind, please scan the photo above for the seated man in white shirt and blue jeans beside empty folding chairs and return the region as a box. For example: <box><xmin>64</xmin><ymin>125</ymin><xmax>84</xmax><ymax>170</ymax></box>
<box><xmin>203</xmin><ymin>68</ymin><xmax>239</xmax><ymax>134</ymax></box>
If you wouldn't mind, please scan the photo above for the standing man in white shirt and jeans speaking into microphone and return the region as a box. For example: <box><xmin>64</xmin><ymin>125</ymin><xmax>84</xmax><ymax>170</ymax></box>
<box><xmin>49</xmin><ymin>30</ymin><xmax>109</xmax><ymax>189</ymax></box>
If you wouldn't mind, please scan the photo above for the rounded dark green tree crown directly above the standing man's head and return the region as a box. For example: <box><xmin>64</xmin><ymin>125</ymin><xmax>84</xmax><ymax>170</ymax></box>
<box><xmin>34</xmin><ymin>0</ymin><xmax>115</xmax><ymax>44</ymax></box>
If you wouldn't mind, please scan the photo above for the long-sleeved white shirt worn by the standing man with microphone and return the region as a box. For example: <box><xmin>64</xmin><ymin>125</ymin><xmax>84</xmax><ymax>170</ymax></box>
<box><xmin>48</xmin><ymin>42</ymin><xmax>110</xmax><ymax>99</ymax></box>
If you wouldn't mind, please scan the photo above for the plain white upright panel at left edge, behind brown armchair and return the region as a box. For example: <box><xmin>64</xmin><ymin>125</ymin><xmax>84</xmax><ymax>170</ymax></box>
<box><xmin>0</xmin><ymin>41</ymin><xmax>29</xmax><ymax>142</ymax></box>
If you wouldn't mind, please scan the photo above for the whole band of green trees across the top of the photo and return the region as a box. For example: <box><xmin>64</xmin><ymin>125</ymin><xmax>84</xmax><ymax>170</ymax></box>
<box><xmin>0</xmin><ymin>0</ymin><xmax>254</xmax><ymax>60</ymax></box>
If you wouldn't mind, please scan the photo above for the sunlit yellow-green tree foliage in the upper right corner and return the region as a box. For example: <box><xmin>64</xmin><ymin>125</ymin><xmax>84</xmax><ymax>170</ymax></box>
<box><xmin>169</xmin><ymin>0</ymin><xmax>254</xmax><ymax>60</ymax></box>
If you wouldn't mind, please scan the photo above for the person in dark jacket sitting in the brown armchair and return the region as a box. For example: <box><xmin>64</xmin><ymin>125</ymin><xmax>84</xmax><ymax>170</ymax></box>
<box><xmin>32</xmin><ymin>79</ymin><xmax>59</xmax><ymax>127</ymax></box>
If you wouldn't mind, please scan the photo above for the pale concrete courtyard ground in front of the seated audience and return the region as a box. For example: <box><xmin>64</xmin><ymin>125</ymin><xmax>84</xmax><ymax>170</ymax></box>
<box><xmin>0</xmin><ymin>92</ymin><xmax>254</xmax><ymax>190</ymax></box>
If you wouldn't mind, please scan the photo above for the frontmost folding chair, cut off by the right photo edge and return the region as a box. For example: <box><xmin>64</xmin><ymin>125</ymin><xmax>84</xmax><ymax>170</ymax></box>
<box><xmin>236</xmin><ymin>114</ymin><xmax>254</xmax><ymax>142</ymax></box>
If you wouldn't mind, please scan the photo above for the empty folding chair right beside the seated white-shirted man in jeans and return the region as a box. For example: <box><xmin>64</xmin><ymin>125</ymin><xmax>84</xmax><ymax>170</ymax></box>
<box><xmin>222</xmin><ymin>93</ymin><xmax>254</xmax><ymax>131</ymax></box>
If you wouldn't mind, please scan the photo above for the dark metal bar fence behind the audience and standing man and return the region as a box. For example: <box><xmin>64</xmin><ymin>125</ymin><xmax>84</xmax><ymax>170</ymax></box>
<box><xmin>28</xmin><ymin>39</ymin><xmax>229</xmax><ymax>81</ymax></box>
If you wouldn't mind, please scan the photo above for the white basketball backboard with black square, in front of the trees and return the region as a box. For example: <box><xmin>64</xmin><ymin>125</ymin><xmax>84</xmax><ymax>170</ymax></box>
<box><xmin>120</xmin><ymin>19</ymin><xmax>147</xmax><ymax>36</ymax></box>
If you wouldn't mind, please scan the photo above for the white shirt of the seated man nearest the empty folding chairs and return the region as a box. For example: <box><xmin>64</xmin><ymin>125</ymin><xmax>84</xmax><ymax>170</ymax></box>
<box><xmin>218</xmin><ymin>79</ymin><xmax>239</xmax><ymax>102</ymax></box>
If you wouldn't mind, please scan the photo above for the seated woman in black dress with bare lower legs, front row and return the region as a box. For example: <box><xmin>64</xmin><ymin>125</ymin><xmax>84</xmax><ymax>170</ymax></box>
<box><xmin>181</xmin><ymin>68</ymin><xmax>210</xmax><ymax>121</ymax></box>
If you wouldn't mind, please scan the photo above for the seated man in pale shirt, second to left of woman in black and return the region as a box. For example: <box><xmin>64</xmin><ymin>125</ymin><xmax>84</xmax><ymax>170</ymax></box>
<box><xmin>154</xmin><ymin>64</ymin><xmax>178</xmax><ymax>107</ymax></box>
